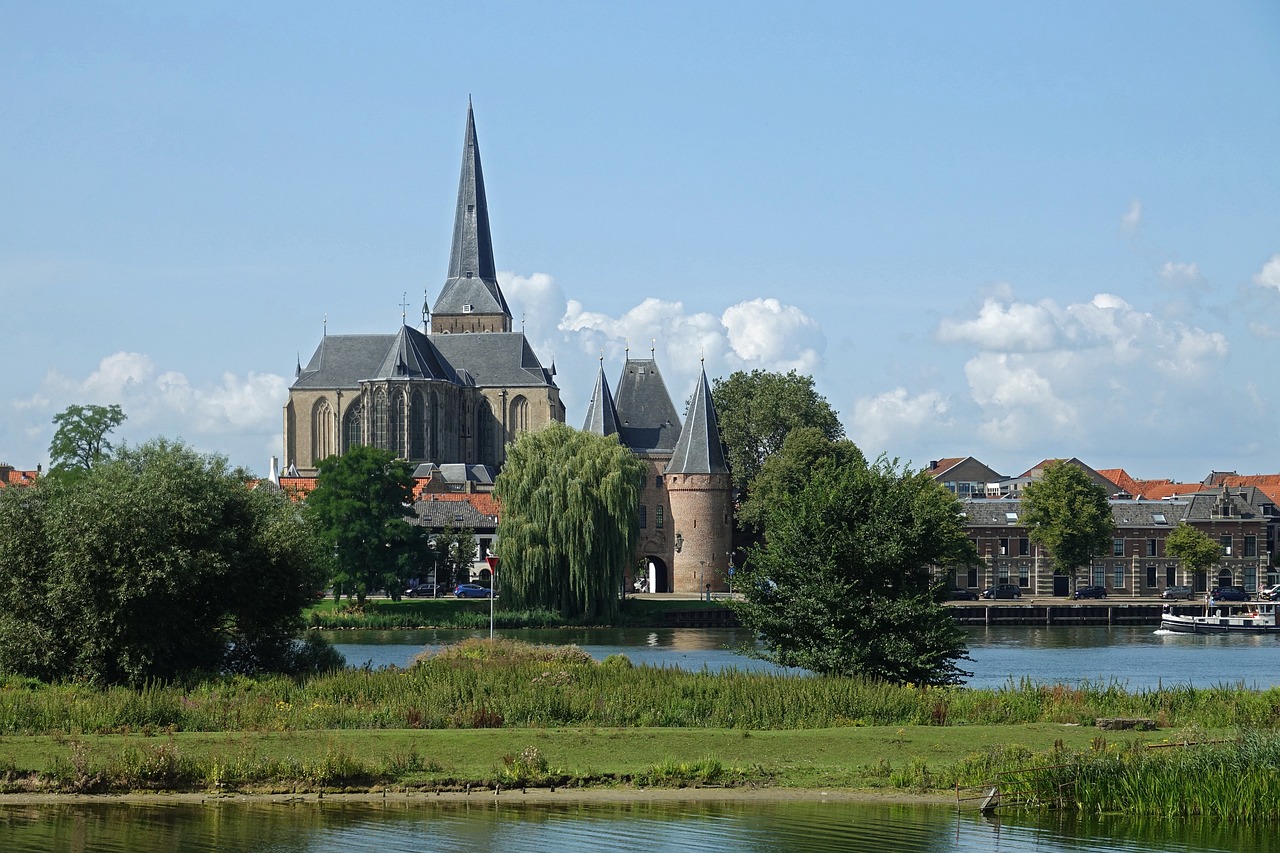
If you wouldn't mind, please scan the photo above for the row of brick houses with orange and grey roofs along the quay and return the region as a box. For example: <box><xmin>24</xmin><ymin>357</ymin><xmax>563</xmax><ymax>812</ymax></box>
<box><xmin>928</xmin><ymin>457</ymin><xmax>1280</xmax><ymax>596</ymax></box>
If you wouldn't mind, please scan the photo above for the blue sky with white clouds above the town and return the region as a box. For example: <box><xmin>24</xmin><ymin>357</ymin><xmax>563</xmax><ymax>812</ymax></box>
<box><xmin>0</xmin><ymin>0</ymin><xmax>1280</xmax><ymax>482</ymax></box>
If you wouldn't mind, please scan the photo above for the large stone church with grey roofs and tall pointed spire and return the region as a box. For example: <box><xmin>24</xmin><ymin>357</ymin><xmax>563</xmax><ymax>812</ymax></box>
<box><xmin>284</xmin><ymin>105</ymin><xmax>564</xmax><ymax>476</ymax></box>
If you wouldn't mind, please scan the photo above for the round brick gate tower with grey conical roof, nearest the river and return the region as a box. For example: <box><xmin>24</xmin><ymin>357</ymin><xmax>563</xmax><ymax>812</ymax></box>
<box><xmin>663</xmin><ymin>370</ymin><xmax>733</xmax><ymax>593</ymax></box>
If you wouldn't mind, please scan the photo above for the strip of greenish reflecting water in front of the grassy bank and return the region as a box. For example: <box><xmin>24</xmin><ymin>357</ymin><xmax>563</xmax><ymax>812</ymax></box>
<box><xmin>0</xmin><ymin>798</ymin><xmax>1271</xmax><ymax>853</ymax></box>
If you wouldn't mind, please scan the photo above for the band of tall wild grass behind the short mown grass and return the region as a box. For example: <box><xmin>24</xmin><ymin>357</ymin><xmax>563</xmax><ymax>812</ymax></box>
<box><xmin>0</xmin><ymin>640</ymin><xmax>1280</xmax><ymax>734</ymax></box>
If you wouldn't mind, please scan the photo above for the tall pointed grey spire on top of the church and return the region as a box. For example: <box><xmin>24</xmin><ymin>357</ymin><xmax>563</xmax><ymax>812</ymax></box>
<box><xmin>431</xmin><ymin>99</ymin><xmax>511</xmax><ymax>332</ymax></box>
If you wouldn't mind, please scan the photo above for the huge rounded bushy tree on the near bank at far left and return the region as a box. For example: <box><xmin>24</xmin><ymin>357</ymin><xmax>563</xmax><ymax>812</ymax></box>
<box><xmin>0</xmin><ymin>439</ymin><xmax>335</xmax><ymax>685</ymax></box>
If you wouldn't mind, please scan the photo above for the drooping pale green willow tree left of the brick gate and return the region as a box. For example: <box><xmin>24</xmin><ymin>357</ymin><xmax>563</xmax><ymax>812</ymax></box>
<box><xmin>494</xmin><ymin>424</ymin><xmax>646</xmax><ymax>620</ymax></box>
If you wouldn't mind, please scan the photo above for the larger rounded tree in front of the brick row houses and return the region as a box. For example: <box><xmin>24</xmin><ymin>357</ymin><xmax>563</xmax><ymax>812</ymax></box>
<box><xmin>1023</xmin><ymin>462</ymin><xmax>1116</xmax><ymax>575</ymax></box>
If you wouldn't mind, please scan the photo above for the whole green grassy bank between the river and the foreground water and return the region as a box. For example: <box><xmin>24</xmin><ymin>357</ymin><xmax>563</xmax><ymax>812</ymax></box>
<box><xmin>0</xmin><ymin>640</ymin><xmax>1280</xmax><ymax>818</ymax></box>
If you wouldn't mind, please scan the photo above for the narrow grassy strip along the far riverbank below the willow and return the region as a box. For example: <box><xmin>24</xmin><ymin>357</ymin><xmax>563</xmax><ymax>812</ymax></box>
<box><xmin>305</xmin><ymin>597</ymin><xmax>724</xmax><ymax>630</ymax></box>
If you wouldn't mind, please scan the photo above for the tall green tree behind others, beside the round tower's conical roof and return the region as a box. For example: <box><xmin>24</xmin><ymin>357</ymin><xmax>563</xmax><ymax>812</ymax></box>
<box><xmin>712</xmin><ymin>370</ymin><xmax>845</xmax><ymax>489</ymax></box>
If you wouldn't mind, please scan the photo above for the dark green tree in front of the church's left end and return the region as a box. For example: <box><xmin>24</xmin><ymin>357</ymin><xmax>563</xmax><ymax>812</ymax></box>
<box><xmin>306</xmin><ymin>444</ymin><xmax>413</xmax><ymax>605</ymax></box>
